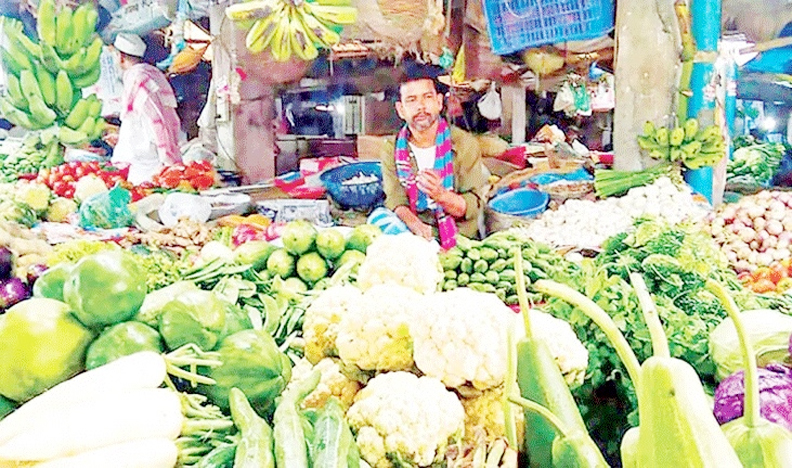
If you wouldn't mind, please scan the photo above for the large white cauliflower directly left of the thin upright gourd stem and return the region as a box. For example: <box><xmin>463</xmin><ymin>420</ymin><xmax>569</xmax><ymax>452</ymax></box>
<box><xmin>410</xmin><ymin>288</ymin><xmax>515</xmax><ymax>390</ymax></box>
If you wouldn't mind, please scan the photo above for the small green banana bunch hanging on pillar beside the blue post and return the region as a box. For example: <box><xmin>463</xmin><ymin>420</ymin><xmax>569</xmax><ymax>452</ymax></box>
<box><xmin>638</xmin><ymin>118</ymin><xmax>726</xmax><ymax>169</ymax></box>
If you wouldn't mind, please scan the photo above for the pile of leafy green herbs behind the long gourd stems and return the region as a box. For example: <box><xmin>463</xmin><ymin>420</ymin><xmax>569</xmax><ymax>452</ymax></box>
<box><xmin>542</xmin><ymin>220</ymin><xmax>758</xmax><ymax>460</ymax></box>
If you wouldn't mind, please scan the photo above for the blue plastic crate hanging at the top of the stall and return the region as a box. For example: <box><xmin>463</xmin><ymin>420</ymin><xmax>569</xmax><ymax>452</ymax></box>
<box><xmin>483</xmin><ymin>0</ymin><xmax>614</xmax><ymax>55</ymax></box>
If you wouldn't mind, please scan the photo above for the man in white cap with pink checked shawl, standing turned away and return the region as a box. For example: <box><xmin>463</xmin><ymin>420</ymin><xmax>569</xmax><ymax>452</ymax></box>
<box><xmin>110</xmin><ymin>33</ymin><xmax>181</xmax><ymax>184</ymax></box>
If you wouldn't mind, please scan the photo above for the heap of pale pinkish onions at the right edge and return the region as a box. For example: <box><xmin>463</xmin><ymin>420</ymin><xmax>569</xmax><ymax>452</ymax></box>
<box><xmin>710</xmin><ymin>190</ymin><xmax>792</xmax><ymax>272</ymax></box>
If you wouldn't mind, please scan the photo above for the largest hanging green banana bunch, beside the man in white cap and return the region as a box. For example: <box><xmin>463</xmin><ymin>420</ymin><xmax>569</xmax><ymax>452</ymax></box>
<box><xmin>0</xmin><ymin>0</ymin><xmax>105</xmax><ymax>145</ymax></box>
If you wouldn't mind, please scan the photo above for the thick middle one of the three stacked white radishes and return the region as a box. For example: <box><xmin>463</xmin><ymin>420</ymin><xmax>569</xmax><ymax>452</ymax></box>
<box><xmin>0</xmin><ymin>388</ymin><xmax>184</xmax><ymax>461</ymax></box>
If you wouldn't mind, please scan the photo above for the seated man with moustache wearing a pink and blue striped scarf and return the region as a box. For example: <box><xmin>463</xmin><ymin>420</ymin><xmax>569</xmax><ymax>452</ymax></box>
<box><xmin>381</xmin><ymin>71</ymin><xmax>486</xmax><ymax>245</ymax></box>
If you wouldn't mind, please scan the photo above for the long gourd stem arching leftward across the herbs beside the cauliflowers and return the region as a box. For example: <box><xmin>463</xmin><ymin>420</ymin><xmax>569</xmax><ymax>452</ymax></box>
<box><xmin>532</xmin><ymin>275</ymin><xmax>641</xmax><ymax>388</ymax></box>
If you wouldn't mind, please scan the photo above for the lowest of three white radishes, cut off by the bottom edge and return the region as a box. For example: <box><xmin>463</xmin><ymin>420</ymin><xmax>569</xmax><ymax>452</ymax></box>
<box><xmin>35</xmin><ymin>439</ymin><xmax>178</xmax><ymax>468</ymax></box>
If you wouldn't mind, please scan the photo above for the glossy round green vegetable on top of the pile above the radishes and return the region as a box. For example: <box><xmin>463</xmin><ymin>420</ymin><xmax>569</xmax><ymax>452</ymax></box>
<box><xmin>63</xmin><ymin>250</ymin><xmax>146</xmax><ymax>327</ymax></box>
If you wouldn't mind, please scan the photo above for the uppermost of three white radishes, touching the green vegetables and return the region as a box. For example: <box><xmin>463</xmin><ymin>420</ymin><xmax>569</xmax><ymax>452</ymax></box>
<box><xmin>0</xmin><ymin>351</ymin><xmax>166</xmax><ymax>445</ymax></box>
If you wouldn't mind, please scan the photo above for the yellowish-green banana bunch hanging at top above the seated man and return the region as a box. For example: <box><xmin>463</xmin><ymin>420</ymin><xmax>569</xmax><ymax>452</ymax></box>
<box><xmin>226</xmin><ymin>0</ymin><xmax>357</xmax><ymax>62</ymax></box>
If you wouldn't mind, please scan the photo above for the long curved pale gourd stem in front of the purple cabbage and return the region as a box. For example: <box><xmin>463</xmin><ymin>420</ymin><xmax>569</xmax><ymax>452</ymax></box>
<box><xmin>707</xmin><ymin>280</ymin><xmax>760</xmax><ymax>427</ymax></box>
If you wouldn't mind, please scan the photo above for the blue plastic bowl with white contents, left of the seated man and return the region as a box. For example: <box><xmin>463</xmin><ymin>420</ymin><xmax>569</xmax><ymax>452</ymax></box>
<box><xmin>319</xmin><ymin>161</ymin><xmax>385</xmax><ymax>210</ymax></box>
